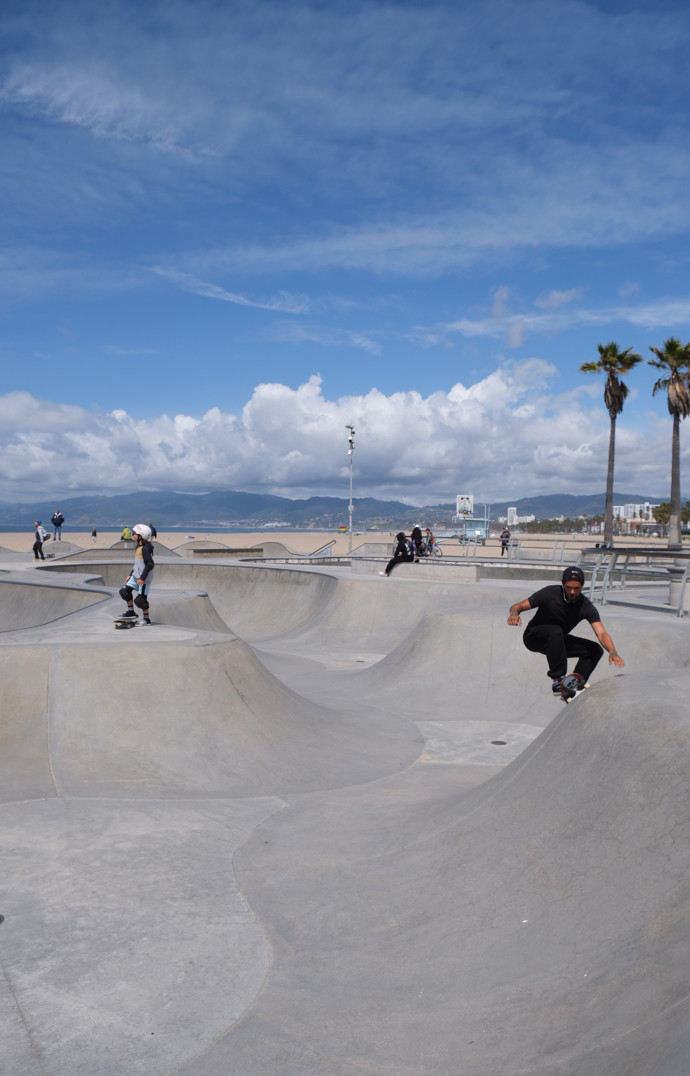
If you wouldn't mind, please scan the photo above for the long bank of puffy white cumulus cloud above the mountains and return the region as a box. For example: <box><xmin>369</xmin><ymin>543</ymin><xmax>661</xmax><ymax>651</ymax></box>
<box><xmin>0</xmin><ymin>358</ymin><xmax>687</xmax><ymax>505</ymax></box>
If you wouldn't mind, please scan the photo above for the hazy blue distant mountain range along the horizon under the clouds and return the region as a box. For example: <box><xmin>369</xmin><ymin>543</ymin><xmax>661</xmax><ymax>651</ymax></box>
<box><xmin>0</xmin><ymin>491</ymin><xmax>667</xmax><ymax>529</ymax></box>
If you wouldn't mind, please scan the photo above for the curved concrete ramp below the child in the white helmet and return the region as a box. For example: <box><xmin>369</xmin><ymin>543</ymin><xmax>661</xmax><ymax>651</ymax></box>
<box><xmin>0</xmin><ymin>628</ymin><xmax>422</xmax><ymax>799</ymax></box>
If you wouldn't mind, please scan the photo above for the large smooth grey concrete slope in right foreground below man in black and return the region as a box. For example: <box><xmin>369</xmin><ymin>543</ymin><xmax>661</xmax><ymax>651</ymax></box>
<box><xmin>194</xmin><ymin>674</ymin><xmax>690</xmax><ymax>1076</ymax></box>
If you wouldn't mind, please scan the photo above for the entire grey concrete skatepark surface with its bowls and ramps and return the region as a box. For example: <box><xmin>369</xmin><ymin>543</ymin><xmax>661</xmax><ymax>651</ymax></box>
<box><xmin>0</xmin><ymin>558</ymin><xmax>690</xmax><ymax>1076</ymax></box>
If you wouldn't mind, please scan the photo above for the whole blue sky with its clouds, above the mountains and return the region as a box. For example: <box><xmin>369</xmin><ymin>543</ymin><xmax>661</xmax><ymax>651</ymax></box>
<box><xmin>0</xmin><ymin>0</ymin><xmax>690</xmax><ymax>504</ymax></box>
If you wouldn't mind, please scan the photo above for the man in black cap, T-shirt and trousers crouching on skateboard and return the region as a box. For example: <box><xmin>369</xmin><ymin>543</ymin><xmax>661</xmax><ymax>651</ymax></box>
<box><xmin>508</xmin><ymin>567</ymin><xmax>625</xmax><ymax>695</ymax></box>
